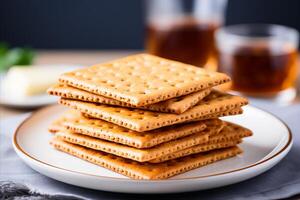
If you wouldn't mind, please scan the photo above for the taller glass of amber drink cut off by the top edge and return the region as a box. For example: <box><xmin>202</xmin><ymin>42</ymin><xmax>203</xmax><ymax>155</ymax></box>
<box><xmin>146</xmin><ymin>0</ymin><xmax>227</xmax><ymax>69</ymax></box>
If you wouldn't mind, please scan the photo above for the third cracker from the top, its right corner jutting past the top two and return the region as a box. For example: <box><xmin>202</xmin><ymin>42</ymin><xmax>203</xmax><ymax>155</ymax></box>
<box><xmin>59</xmin><ymin>91</ymin><xmax>248</xmax><ymax>132</ymax></box>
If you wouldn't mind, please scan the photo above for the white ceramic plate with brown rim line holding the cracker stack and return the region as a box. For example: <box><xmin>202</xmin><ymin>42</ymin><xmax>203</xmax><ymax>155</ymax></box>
<box><xmin>13</xmin><ymin>105</ymin><xmax>292</xmax><ymax>193</ymax></box>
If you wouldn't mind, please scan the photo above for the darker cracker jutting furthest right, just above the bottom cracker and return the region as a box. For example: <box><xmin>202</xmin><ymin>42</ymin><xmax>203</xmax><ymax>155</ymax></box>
<box><xmin>149</xmin><ymin>122</ymin><xmax>252</xmax><ymax>163</ymax></box>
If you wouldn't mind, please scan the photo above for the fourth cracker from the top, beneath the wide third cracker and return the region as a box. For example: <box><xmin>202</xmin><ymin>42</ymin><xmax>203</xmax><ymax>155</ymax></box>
<box><xmin>53</xmin><ymin>110</ymin><xmax>220</xmax><ymax>148</ymax></box>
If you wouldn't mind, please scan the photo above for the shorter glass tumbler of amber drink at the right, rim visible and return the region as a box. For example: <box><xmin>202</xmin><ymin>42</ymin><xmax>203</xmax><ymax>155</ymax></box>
<box><xmin>215</xmin><ymin>24</ymin><xmax>299</xmax><ymax>101</ymax></box>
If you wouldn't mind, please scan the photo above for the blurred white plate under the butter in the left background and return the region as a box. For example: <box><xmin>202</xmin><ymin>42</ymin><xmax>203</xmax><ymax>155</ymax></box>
<box><xmin>0</xmin><ymin>64</ymin><xmax>82</xmax><ymax>108</ymax></box>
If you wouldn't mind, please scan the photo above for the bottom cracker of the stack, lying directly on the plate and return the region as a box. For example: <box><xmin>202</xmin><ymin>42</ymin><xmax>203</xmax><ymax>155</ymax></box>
<box><xmin>50</xmin><ymin>139</ymin><xmax>242</xmax><ymax>180</ymax></box>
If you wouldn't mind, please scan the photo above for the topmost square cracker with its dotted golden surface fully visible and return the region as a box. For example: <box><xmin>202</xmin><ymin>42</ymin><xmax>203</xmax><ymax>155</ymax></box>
<box><xmin>59</xmin><ymin>54</ymin><xmax>230</xmax><ymax>106</ymax></box>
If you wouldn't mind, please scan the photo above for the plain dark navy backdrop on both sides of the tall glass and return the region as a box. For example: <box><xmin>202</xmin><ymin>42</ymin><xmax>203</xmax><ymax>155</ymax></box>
<box><xmin>0</xmin><ymin>0</ymin><xmax>300</xmax><ymax>50</ymax></box>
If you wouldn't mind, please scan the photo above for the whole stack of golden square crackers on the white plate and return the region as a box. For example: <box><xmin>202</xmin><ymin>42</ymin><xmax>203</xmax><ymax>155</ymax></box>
<box><xmin>48</xmin><ymin>54</ymin><xmax>252</xmax><ymax>179</ymax></box>
